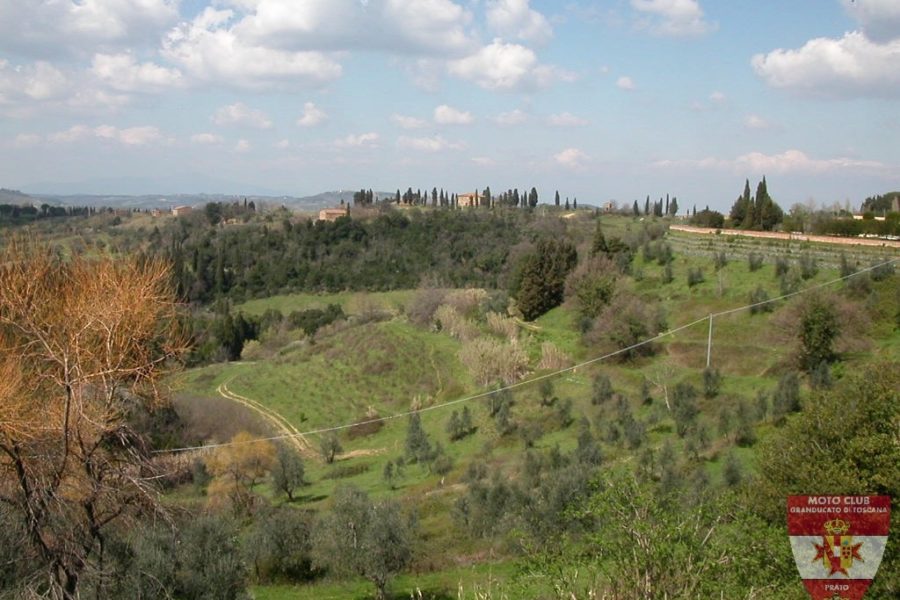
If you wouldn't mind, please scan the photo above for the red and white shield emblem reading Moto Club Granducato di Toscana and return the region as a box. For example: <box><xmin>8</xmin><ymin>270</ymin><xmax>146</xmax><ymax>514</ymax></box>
<box><xmin>788</xmin><ymin>496</ymin><xmax>891</xmax><ymax>600</ymax></box>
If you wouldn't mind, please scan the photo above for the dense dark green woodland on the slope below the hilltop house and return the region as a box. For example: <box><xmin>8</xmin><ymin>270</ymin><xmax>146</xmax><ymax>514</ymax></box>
<box><xmin>161</xmin><ymin>211</ymin><xmax>528</xmax><ymax>303</ymax></box>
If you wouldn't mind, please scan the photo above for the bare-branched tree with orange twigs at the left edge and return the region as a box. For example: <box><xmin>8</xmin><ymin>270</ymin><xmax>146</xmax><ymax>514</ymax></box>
<box><xmin>0</xmin><ymin>239</ymin><xmax>185</xmax><ymax>600</ymax></box>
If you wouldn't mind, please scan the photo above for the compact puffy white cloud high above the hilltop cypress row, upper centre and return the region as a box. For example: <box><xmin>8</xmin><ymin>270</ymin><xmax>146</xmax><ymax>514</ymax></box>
<box><xmin>448</xmin><ymin>39</ymin><xmax>574</xmax><ymax>91</ymax></box>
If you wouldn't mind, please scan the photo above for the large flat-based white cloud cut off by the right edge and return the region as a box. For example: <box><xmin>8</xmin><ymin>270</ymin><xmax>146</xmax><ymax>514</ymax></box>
<box><xmin>751</xmin><ymin>31</ymin><xmax>900</xmax><ymax>97</ymax></box>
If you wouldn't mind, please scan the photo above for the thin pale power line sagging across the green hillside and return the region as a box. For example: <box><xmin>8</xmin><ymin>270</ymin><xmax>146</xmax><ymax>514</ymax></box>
<box><xmin>153</xmin><ymin>258</ymin><xmax>900</xmax><ymax>454</ymax></box>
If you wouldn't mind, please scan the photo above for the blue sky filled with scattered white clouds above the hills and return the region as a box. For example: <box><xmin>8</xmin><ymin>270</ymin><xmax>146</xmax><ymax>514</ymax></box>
<box><xmin>0</xmin><ymin>0</ymin><xmax>900</xmax><ymax>211</ymax></box>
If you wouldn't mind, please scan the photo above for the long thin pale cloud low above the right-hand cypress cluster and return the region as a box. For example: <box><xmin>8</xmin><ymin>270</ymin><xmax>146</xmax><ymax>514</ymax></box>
<box><xmin>653</xmin><ymin>149</ymin><xmax>888</xmax><ymax>175</ymax></box>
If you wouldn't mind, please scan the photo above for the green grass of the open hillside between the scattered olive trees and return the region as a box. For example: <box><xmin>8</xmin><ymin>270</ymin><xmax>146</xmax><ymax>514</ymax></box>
<box><xmin>167</xmin><ymin>219</ymin><xmax>900</xmax><ymax>599</ymax></box>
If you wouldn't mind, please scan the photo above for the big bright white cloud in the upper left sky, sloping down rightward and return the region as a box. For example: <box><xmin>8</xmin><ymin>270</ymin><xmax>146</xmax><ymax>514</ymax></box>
<box><xmin>162</xmin><ymin>7</ymin><xmax>342</xmax><ymax>89</ymax></box>
